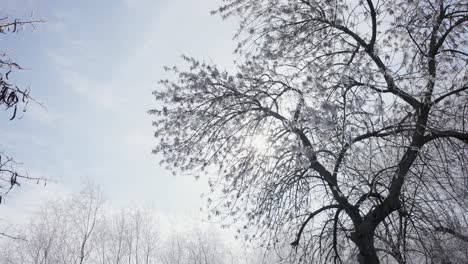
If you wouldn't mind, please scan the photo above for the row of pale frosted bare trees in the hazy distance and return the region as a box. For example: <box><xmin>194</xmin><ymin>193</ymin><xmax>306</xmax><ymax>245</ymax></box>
<box><xmin>0</xmin><ymin>185</ymin><xmax>278</xmax><ymax>264</ymax></box>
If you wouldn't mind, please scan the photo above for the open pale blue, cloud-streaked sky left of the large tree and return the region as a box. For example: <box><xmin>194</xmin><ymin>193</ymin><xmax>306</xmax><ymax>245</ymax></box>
<box><xmin>0</xmin><ymin>0</ymin><xmax>236</xmax><ymax>224</ymax></box>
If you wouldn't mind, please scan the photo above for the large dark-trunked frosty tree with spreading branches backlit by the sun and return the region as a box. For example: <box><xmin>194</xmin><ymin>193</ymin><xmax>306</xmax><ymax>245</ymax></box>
<box><xmin>151</xmin><ymin>0</ymin><xmax>468</xmax><ymax>263</ymax></box>
